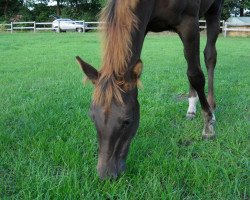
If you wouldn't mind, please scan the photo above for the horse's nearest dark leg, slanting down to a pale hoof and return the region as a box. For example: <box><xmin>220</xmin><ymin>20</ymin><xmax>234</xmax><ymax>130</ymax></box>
<box><xmin>176</xmin><ymin>16</ymin><xmax>215</xmax><ymax>139</ymax></box>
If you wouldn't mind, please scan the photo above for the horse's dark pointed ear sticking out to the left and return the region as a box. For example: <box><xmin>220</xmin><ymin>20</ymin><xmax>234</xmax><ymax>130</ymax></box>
<box><xmin>76</xmin><ymin>56</ymin><xmax>100</xmax><ymax>84</ymax></box>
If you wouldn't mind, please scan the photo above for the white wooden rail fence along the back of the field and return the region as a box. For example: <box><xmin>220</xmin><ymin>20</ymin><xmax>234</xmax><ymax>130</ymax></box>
<box><xmin>0</xmin><ymin>20</ymin><xmax>250</xmax><ymax>37</ymax></box>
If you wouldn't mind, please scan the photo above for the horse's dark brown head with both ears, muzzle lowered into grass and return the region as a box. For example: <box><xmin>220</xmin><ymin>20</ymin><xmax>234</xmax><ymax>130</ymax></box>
<box><xmin>77</xmin><ymin>57</ymin><xmax>142</xmax><ymax>179</ymax></box>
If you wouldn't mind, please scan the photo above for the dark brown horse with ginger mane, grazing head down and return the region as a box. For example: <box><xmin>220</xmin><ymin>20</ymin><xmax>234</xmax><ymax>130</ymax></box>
<box><xmin>76</xmin><ymin>0</ymin><xmax>223</xmax><ymax>179</ymax></box>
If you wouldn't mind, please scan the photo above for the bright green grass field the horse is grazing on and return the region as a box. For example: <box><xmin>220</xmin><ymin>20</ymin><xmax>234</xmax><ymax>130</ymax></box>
<box><xmin>0</xmin><ymin>33</ymin><xmax>250</xmax><ymax>200</ymax></box>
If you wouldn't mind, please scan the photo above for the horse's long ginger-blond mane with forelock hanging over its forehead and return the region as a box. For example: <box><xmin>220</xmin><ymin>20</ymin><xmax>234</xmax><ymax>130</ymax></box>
<box><xmin>93</xmin><ymin>0</ymin><xmax>138</xmax><ymax>107</ymax></box>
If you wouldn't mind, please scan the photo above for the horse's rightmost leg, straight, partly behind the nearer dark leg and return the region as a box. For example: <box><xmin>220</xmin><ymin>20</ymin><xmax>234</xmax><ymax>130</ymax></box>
<box><xmin>204</xmin><ymin>14</ymin><xmax>220</xmax><ymax>110</ymax></box>
